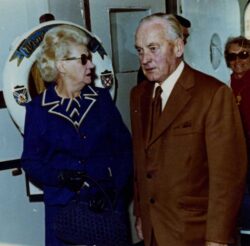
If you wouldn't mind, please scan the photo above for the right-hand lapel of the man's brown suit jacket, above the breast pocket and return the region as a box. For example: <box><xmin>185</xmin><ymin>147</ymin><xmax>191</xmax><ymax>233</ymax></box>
<box><xmin>148</xmin><ymin>65</ymin><xmax>194</xmax><ymax>146</ymax></box>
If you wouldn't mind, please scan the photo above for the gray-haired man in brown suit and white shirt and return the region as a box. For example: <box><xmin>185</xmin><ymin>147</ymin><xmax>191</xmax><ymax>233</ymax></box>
<box><xmin>131</xmin><ymin>14</ymin><xmax>247</xmax><ymax>246</ymax></box>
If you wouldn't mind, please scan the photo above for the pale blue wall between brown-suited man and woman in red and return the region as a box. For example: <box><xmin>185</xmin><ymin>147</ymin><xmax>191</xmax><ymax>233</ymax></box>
<box><xmin>179</xmin><ymin>0</ymin><xmax>241</xmax><ymax>83</ymax></box>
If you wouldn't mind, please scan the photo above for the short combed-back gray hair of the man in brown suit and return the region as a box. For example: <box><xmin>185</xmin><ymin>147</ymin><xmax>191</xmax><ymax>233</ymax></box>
<box><xmin>138</xmin><ymin>13</ymin><xmax>183</xmax><ymax>41</ymax></box>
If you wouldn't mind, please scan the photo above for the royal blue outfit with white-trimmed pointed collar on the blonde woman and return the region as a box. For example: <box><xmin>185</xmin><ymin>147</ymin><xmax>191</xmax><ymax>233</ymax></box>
<box><xmin>22</xmin><ymin>85</ymin><xmax>132</xmax><ymax>246</ymax></box>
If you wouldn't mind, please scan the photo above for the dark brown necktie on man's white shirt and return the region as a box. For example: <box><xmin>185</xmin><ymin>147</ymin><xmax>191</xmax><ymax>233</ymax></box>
<box><xmin>151</xmin><ymin>86</ymin><xmax>162</xmax><ymax>136</ymax></box>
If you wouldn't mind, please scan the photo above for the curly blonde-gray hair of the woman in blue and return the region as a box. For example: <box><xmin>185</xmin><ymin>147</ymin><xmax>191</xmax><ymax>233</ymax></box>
<box><xmin>37</xmin><ymin>25</ymin><xmax>89</xmax><ymax>82</ymax></box>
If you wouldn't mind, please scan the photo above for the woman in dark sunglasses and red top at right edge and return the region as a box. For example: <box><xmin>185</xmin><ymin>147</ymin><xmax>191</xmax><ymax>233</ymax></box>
<box><xmin>225</xmin><ymin>36</ymin><xmax>250</xmax><ymax>246</ymax></box>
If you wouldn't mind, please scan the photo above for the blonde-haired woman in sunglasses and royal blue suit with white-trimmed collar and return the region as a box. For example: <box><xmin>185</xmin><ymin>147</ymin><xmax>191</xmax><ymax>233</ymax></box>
<box><xmin>22</xmin><ymin>25</ymin><xmax>132</xmax><ymax>246</ymax></box>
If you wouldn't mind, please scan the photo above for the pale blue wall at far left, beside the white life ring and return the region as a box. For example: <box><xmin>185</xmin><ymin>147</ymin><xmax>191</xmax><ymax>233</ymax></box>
<box><xmin>0</xmin><ymin>0</ymin><xmax>48</xmax><ymax>246</ymax></box>
